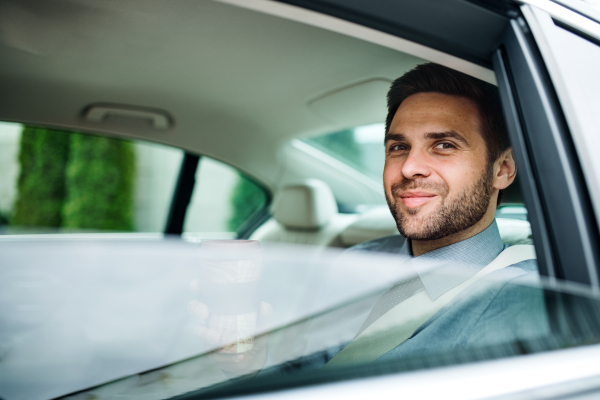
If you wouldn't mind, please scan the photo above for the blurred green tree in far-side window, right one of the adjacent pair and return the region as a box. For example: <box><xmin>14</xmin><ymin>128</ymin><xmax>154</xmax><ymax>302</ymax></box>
<box><xmin>62</xmin><ymin>134</ymin><xmax>135</xmax><ymax>231</ymax></box>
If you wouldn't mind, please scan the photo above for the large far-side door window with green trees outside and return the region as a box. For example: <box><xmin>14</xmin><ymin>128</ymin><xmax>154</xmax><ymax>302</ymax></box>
<box><xmin>0</xmin><ymin>123</ymin><xmax>166</xmax><ymax>233</ymax></box>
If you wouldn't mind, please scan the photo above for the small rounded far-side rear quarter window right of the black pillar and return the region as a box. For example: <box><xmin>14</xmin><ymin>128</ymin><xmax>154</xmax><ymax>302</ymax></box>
<box><xmin>183</xmin><ymin>156</ymin><xmax>267</xmax><ymax>238</ymax></box>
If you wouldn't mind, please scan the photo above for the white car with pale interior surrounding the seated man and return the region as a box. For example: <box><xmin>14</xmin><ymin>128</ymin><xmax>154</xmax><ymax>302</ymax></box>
<box><xmin>0</xmin><ymin>0</ymin><xmax>600</xmax><ymax>400</ymax></box>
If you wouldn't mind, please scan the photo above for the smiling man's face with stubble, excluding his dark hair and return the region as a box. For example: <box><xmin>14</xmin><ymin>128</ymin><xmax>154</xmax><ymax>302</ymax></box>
<box><xmin>383</xmin><ymin>93</ymin><xmax>493</xmax><ymax>240</ymax></box>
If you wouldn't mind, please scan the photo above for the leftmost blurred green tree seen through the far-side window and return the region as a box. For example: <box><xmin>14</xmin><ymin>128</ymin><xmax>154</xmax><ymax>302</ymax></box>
<box><xmin>10</xmin><ymin>126</ymin><xmax>70</xmax><ymax>227</ymax></box>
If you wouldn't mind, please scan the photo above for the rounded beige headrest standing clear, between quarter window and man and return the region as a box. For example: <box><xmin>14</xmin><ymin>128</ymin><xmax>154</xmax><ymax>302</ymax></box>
<box><xmin>273</xmin><ymin>179</ymin><xmax>337</xmax><ymax>229</ymax></box>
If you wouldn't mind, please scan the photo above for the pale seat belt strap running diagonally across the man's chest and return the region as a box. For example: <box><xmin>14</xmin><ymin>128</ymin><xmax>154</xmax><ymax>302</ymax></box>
<box><xmin>323</xmin><ymin>245</ymin><xmax>536</xmax><ymax>368</ymax></box>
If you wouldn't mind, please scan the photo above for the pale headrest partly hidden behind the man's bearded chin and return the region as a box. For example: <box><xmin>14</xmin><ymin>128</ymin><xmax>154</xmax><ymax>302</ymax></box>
<box><xmin>340</xmin><ymin>206</ymin><xmax>398</xmax><ymax>247</ymax></box>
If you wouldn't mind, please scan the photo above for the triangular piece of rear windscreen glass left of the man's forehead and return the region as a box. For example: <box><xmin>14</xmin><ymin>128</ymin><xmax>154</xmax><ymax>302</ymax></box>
<box><xmin>305</xmin><ymin>124</ymin><xmax>385</xmax><ymax>181</ymax></box>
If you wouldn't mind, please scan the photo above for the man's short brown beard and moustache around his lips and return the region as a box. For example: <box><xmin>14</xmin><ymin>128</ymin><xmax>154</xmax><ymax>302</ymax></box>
<box><xmin>385</xmin><ymin>164</ymin><xmax>494</xmax><ymax>240</ymax></box>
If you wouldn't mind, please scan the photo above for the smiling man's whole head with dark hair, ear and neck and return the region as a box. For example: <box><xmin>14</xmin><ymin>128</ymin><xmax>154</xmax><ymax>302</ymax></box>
<box><xmin>383</xmin><ymin>64</ymin><xmax>516</xmax><ymax>256</ymax></box>
